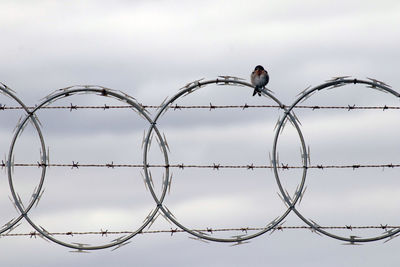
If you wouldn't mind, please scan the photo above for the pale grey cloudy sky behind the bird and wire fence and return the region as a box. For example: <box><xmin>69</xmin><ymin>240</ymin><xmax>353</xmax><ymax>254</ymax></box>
<box><xmin>0</xmin><ymin>0</ymin><xmax>400</xmax><ymax>266</ymax></box>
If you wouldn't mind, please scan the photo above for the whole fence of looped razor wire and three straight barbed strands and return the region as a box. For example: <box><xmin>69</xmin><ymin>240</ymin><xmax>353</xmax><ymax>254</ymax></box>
<box><xmin>0</xmin><ymin>76</ymin><xmax>400</xmax><ymax>251</ymax></box>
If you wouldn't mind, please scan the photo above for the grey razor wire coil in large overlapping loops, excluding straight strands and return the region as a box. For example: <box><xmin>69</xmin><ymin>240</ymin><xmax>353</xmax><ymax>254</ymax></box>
<box><xmin>0</xmin><ymin>76</ymin><xmax>400</xmax><ymax>251</ymax></box>
